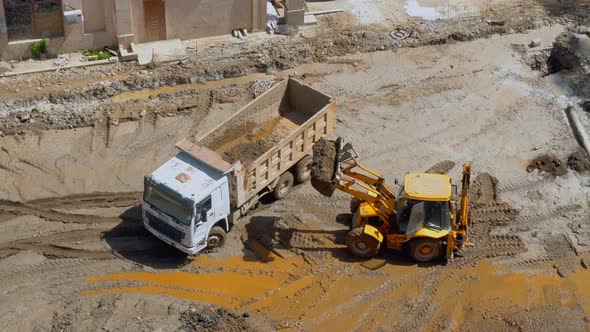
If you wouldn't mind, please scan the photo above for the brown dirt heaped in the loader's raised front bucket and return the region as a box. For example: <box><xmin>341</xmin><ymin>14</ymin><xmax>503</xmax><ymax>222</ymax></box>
<box><xmin>311</xmin><ymin>138</ymin><xmax>337</xmax><ymax>197</ymax></box>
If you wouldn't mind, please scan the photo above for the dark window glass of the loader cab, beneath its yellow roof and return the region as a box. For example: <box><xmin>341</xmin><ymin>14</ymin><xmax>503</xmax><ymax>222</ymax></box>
<box><xmin>406</xmin><ymin>202</ymin><xmax>451</xmax><ymax>234</ymax></box>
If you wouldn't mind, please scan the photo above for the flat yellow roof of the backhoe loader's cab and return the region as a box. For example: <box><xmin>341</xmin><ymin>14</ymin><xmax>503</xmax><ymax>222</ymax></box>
<box><xmin>404</xmin><ymin>173</ymin><xmax>451</xmax><ymax>202</ymax></box>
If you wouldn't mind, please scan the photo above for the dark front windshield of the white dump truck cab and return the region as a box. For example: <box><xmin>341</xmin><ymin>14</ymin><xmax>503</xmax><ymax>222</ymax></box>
<box><xmin>143</xmin><ymin>181</ymin><xmax>193</xmax><ymax>226</ymax></box>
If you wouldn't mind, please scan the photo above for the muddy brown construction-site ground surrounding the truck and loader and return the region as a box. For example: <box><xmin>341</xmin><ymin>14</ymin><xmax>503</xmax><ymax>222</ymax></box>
<box><xmin>0</xmin><ymin>1</ymin><xmax>590</xmax><ymax>331</ymax></box>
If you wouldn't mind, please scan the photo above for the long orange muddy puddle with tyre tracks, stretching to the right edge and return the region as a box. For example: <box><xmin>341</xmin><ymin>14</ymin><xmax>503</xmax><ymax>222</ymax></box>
<box><xmin>84</xmin><ymin>255</ymin><xmax>590</xmax><ymax>331</ymax></box>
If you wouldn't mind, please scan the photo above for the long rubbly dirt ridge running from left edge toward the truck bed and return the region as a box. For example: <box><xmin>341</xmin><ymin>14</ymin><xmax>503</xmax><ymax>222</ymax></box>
<box><xmin>0</xmin><ymin>84</ymin><xmax>253</xmax><ymax>136</ymax></box>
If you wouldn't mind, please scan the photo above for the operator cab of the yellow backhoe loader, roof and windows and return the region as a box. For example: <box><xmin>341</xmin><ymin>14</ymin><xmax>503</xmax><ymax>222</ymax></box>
<box><xmin>400</xmin><ymin>173</ymin><xmax>453</xmax><ymax>236</ymax></box>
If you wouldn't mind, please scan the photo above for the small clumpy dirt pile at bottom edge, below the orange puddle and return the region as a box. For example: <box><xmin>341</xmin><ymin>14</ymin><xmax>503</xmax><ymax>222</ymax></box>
<box><xmin>179</xmin><ymin>306</ymin><xmax>257</xmax><ymax>332</ymax></box>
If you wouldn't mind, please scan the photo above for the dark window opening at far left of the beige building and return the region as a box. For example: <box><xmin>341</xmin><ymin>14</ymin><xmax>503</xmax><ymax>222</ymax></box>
<box><xmin>3</xmin><ymin>0</ymin><xmax>64</xmax><ymax>41</ymax></box>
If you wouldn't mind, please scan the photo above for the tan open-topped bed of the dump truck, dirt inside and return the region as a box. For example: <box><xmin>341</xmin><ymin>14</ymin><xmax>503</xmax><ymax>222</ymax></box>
<box><xmin>179</xmin><ymin>79</ymin><xmax>336</xmax><ymax>208</ymax></box>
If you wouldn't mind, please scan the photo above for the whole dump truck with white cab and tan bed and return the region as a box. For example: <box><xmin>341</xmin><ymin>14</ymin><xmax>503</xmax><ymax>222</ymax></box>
<box><xmin>142</xmin><ymin>78</ymin><xmax>336</xmax><ymax>255</ymax></box>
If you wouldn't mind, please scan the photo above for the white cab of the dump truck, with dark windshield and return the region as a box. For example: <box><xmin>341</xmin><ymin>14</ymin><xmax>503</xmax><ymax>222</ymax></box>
<box><xmin>142</xmin><ymin>151</ymin><xmax>230</xmax><ymax>255</ymax></box>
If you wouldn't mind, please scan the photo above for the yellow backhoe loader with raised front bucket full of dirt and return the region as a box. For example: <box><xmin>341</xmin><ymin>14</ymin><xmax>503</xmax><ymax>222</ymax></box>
<box><xmin>312</xmin><ymin>138</ymin><xmax>471</xmax><ymax>262</ymax></box>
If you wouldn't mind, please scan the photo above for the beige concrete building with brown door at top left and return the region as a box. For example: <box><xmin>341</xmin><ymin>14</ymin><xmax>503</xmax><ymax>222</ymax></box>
<box><xmin>0</xmin><ymin>0</ymin><xmax>266</xmax><ymax>59</ymax></box>
